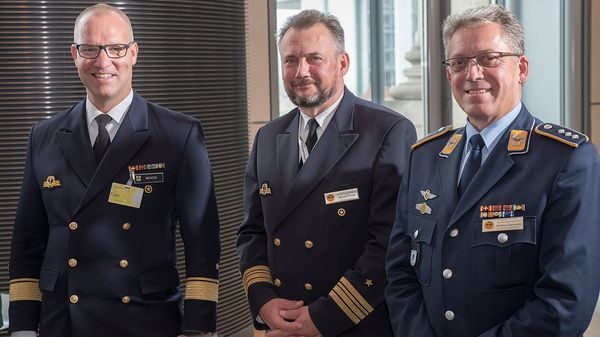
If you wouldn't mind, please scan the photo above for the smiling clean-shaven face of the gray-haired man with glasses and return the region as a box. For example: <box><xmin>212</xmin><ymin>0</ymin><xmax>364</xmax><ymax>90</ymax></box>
<box><xmin>446</xmin><ymin>23</ymin><xmax>528</xmax><ymax>131</ymax></box>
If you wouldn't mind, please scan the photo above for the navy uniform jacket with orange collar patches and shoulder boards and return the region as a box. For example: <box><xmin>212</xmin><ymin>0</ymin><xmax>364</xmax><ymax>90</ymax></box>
<box><xmin>386</xmin><ymin>107</ymin><xmax>600</xmax><ymax>337</ymax></box>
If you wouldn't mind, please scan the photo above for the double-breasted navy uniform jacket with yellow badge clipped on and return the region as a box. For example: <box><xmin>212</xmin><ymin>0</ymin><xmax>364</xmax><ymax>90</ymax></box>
<box><xmin>10</xmin><ymin>94</ymin><xmax>220</xmax><ymax>337</ymax></box>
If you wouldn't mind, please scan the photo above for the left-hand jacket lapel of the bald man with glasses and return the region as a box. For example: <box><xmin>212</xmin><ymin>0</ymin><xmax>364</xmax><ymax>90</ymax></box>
<box><xmin>56</xmin><ymin>99</ymin><xmax>96</xmax><ymax>187</ymax></box>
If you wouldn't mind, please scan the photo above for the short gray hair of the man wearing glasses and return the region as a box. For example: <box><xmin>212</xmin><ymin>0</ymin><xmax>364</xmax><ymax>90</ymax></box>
<box><xmin>442</xmin><ymin>5</ymin><xmax>525</xmax><ymax>57</ymax></box>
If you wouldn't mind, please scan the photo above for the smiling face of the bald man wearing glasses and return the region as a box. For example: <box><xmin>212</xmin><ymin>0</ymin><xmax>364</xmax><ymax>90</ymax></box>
<box><xmin>71</xmin><ymin>11</ymin><xmax>138</xmax><ymax>112</ymax></box>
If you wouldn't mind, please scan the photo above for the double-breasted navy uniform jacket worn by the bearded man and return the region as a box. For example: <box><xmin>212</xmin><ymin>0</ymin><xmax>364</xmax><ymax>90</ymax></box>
<box><xmin>237</xmin><ymin>89</ymin><xmax>416</xmax><ymax>337</ymax></box>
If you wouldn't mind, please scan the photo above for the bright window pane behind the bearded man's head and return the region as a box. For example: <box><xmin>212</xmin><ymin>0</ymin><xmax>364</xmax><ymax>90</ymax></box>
<box><xmin>276</xmin><ymin>0</ymin><xmax>371</xmax><ymax>115</ymax></box>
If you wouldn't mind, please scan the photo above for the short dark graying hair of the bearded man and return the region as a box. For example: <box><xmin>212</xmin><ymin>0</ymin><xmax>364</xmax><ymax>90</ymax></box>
<box><xmin>277</xmin><ymin>9</ymin><xmax>345</xmax><ymax>53</ymax></box>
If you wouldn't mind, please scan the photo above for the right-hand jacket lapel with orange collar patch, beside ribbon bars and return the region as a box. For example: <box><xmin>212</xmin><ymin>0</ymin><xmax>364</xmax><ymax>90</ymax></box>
<box><xmin>447</xmin><ymin>105</ymin><xmax>535</xmax><ymax>228</ymax></box>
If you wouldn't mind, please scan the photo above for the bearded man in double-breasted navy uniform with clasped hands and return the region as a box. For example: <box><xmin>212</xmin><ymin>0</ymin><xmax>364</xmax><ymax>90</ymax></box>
<box><xmin>237</xmin><ymin>10</ymin><xmax>416</xmax><ymax>337</ymax></box>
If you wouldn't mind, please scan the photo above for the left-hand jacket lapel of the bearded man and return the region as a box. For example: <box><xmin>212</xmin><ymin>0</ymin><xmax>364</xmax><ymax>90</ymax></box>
<box><xmin>277</xmin><ymin>109</ymin><xmax>300</xmax><ymax>195</ymax></box>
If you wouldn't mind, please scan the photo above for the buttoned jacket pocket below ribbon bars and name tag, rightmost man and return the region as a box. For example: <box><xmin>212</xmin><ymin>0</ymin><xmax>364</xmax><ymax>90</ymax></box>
<box><xmin>471</xmin><ymin>216</ymin><xmax>538</xmax><ymax>291</ymax></box>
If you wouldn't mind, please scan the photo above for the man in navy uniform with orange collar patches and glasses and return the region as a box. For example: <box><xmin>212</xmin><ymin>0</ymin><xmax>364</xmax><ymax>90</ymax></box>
<box><xmin>386</xmin><ymin>5</ymin><xmax>600</xmax><ymax>337</ymax></box>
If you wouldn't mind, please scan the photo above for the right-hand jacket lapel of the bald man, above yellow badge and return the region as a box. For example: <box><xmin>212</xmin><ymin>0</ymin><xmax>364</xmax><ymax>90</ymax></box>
<box><xmin>75</xmin><ymin>93</ymin><xmax>150</xmax><ymax>213</ymax></box>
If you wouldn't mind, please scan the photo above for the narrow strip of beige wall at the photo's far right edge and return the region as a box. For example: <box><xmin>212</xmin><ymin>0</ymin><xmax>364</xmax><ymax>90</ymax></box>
<box><xmin>590</xmin><ymin>1</ymin><xmax>600</xmax><ymax>147</ymax></box>
